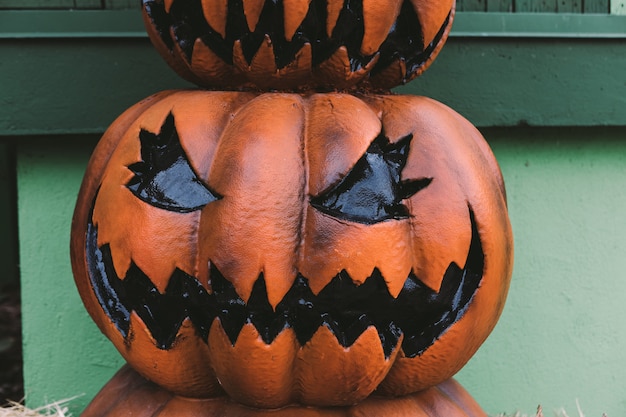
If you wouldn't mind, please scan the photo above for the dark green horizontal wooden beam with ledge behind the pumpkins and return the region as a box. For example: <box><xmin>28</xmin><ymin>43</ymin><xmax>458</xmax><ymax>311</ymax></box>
<box><xmin>0</xmin><ymin>9</ymin><xmax>626</xmax><ymax>136</ymax></box>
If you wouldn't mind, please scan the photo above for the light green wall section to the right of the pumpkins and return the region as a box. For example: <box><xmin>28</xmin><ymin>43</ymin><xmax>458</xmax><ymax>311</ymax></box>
<box><xmin>459</xmin><ymin>128</ymin><xmax>626</xmax><ymax>417</ymax></box>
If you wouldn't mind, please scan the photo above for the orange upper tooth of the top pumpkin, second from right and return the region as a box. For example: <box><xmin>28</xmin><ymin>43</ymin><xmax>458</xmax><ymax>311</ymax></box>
<box><xmin>361</xmin><ymin>0</ymin><xmax>402</xmax><ymax>56</ymax></box>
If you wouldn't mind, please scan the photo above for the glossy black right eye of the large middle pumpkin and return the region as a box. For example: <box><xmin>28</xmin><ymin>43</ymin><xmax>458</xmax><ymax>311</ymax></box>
<box><xmin>311</xmin><ymin>133</ymin><xmax>432</xmax><ymax>224</ymax></box>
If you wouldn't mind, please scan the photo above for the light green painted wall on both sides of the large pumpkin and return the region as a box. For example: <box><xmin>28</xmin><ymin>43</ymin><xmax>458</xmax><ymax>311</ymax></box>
<box><xmin>17</xmin><ymin>127</ymin><xmax>626</xmax><ymax>417</ymax></box>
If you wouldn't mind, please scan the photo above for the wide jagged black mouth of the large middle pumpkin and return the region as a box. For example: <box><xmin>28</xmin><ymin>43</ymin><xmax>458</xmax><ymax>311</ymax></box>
<box><xmin>86</xmin><ymin>207</ymin><xmax>484</xmax><ymax>357</ymax></box>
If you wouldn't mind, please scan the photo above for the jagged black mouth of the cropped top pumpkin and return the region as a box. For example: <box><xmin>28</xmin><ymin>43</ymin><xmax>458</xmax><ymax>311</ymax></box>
<box><xmin>143</xmin><ymin>0</ymin><xmax>451</xmax><ymax>79</ymax></box>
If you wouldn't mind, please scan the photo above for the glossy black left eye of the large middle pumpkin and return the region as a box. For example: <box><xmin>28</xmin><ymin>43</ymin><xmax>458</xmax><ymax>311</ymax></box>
<box><xmin>126</xmin><ymin>113</ymin><xmax>221</xmax><ymax>213</ymax></box>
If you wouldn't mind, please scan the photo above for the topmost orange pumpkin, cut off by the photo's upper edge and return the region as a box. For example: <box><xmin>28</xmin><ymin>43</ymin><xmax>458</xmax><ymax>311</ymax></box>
<box><xmin>143</xmin><ymin>0</ymin><xmax>455</xmax><ymax>90</ymax></box>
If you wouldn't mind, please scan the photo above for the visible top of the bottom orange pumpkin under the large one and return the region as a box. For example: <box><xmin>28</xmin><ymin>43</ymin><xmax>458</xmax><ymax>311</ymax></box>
<box><xmin>81</xmin><ymin>365</ymin><xmax>487</xmax><ymax>417</ymax></box>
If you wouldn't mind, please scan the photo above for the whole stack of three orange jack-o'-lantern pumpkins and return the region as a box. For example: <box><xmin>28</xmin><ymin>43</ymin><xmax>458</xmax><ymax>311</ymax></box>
<box><xmin>71</xmin><ymin>0</ymin><xmax>512</xmax><ymax>417</ymax></box>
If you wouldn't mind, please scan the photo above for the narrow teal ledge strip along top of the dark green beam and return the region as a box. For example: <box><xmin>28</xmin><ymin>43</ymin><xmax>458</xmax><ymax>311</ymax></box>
<box><xmin>0</xmin><ymin>10</ymin><xmax>626</xmax><ymax>39</ymax></box>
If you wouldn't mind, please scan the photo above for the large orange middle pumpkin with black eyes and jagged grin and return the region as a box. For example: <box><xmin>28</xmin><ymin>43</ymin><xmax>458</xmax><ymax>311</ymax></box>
<box><xmin>72</xmin><ymin>91</ymin><xmax>512</xmax><ymax>408</ymax></box>
